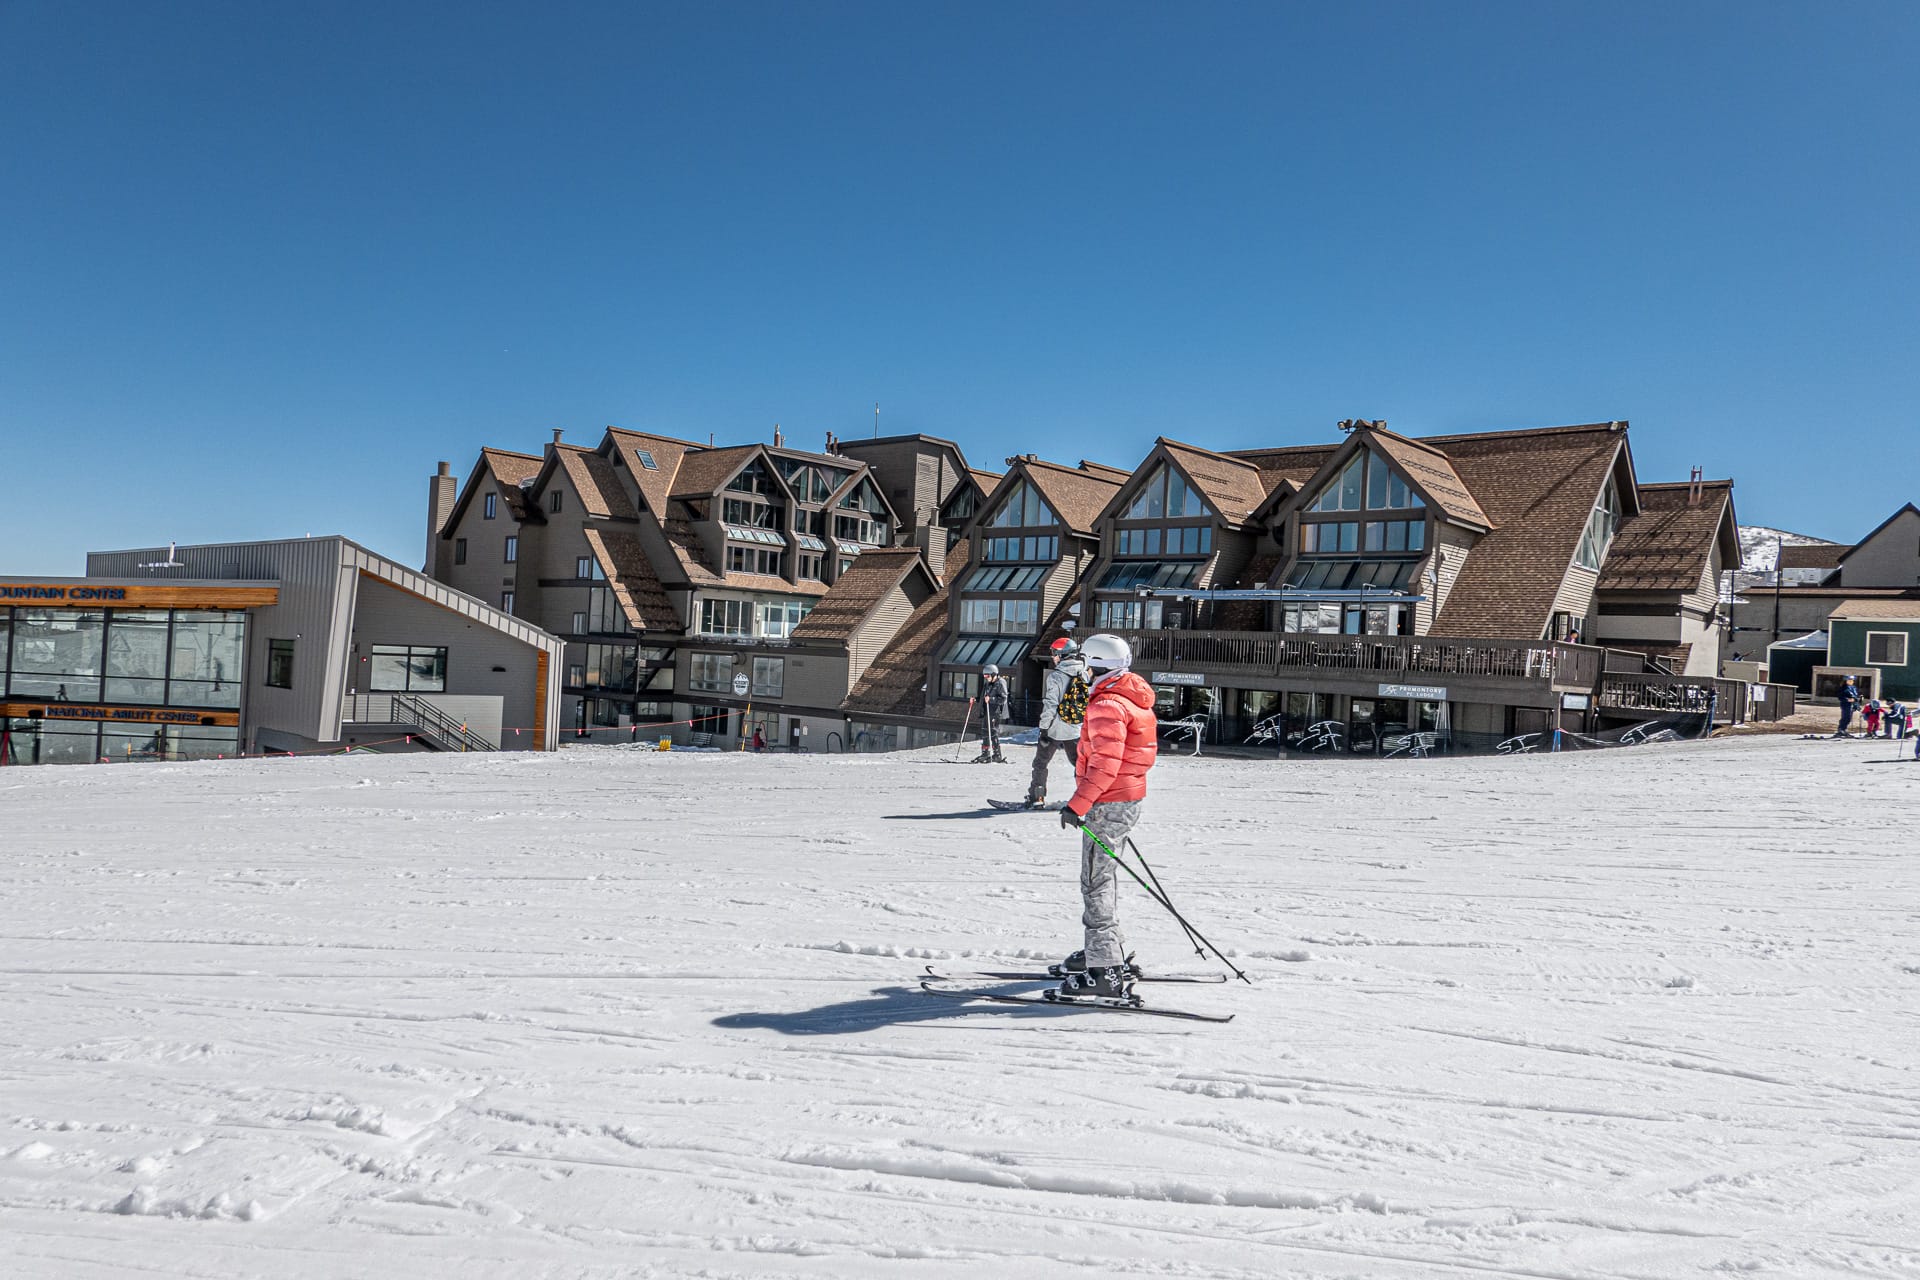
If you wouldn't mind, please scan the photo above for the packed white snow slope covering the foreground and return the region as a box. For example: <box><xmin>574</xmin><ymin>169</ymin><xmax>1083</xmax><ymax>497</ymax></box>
<box><xmin>0</xmin><ymin>739</ymin><xmax>1920</xmax><ymax>1280</ymax></box>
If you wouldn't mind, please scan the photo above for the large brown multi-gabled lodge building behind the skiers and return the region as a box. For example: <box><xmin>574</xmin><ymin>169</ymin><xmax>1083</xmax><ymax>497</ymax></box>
<box><xmin>426</xmin><ymin>422</ymin><xmax>1778</xmax><ymax>754</ymax></box>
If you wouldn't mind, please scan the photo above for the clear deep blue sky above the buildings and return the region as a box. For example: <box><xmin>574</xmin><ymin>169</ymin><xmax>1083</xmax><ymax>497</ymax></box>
<box><xmin>0</xmin><ymin>0</ymin><xmax>1920</xmax><ymax>574</ymax></box>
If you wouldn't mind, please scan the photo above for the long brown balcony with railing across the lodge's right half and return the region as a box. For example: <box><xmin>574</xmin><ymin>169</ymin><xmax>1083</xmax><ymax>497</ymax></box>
<box><xmin>1119</xmin><ymin>631</ymin><xmax>1603</xmax><ymax>697</ymax></box>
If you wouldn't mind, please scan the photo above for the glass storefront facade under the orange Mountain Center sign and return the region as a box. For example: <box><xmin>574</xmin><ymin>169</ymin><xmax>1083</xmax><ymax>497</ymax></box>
<box><xmin>0</xmin><ymin>608</ymin><xmax>246</xmax><ymax>766</ymax></box>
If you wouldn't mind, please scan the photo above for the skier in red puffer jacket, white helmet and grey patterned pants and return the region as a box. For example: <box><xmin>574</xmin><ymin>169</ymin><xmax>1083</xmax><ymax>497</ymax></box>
<box><xmin>1060</xmin><ymin>635</ymin><xmax>1160</xmax><ymax>996</ymax></box>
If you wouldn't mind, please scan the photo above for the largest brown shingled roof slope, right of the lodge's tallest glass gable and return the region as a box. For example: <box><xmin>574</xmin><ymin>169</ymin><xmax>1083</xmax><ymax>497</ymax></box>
<box><xmin>1423</xmin><ymin>422</ymin><xmax>1638</xmax><ymax>639</ymax></box>
